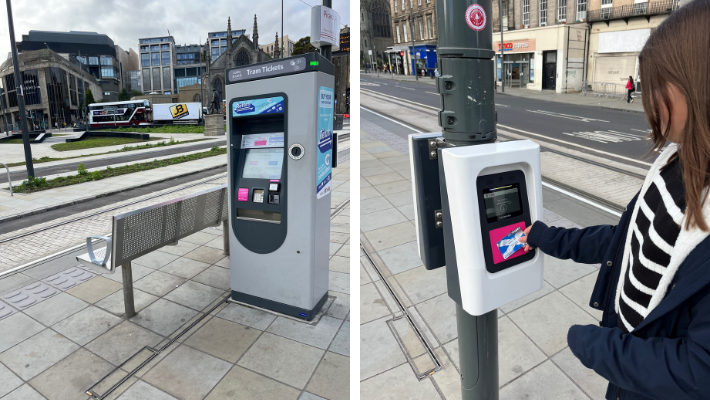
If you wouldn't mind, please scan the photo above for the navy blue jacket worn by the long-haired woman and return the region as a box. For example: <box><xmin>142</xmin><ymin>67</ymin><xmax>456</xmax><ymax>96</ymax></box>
<box><xmin>528</xmin><ymin>195</ymin><xmax>710</xmax><ymax>400</ymax></box>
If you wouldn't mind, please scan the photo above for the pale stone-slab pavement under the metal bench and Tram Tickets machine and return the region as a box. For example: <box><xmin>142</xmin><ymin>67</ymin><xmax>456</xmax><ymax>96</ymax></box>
<box><xmin>0</xmin><ymin>161</ymin><xmax>350</xmax><ymax>400</ymax></box>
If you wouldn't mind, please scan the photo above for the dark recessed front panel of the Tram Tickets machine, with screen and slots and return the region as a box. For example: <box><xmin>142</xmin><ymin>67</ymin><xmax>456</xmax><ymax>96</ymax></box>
<box><xmin>229</xmin><ymin>95</ymin><xmax>288</xmax><ymax>254</ymax></box>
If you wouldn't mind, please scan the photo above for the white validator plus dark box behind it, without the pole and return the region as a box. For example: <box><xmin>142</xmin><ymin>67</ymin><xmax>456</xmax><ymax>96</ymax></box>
<box><xmin>409</xmin><ymin>138</ymin><xmax>543</xmax><ymax>315</ymax></box>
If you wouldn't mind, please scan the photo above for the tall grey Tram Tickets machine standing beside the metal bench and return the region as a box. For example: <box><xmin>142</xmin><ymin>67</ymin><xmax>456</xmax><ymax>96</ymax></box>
<box><xmin>226</xmin><ymin>53</ymin><xmax>334</xmax><ymax>320</ymax></box>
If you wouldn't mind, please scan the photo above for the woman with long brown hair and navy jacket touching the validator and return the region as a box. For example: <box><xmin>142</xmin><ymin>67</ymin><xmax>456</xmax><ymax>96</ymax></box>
<box><xmin>521</xmin><ymin>0</ymin><xmax>710</xmax><ymax>400</ymax></box>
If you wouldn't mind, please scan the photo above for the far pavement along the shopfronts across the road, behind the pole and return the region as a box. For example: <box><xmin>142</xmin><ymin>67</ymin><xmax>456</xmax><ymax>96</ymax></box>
<box><xmin>360</xmin><ymin>71</ymin><xmax>644</xmax><ymax>114</ymax></box>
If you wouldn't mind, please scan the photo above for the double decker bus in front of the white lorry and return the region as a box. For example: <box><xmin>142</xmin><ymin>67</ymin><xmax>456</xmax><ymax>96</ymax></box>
<box><xmin>89</xmin><ymin>100</ymin><xmax>153</xmax><ymax>128</ymax></box>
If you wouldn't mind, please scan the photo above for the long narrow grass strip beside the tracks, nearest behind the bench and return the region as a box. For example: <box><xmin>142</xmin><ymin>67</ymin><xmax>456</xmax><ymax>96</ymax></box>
<box><xmin>13</xmin><ymin>146</ymin><xmax>227</xmax><ymax>193</ymax></box>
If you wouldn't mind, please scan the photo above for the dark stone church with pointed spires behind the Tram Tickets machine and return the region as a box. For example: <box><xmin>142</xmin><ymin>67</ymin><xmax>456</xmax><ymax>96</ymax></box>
<box><xmin>202</xmin><ymin>15</ymin><xmax>278</xmax><ymax>107</ymax></box>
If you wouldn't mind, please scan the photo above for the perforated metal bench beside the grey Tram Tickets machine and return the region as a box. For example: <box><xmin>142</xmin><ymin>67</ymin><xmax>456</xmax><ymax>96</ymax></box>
<box><xmin>76</xmin><ymin>185</ymin><xmax>229</xmax><ymax>318</ymax></box>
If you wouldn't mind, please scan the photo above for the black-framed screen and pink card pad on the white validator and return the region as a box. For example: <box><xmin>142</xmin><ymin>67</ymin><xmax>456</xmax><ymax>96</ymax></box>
<box><xmin>476</xmin><ymin>170</ymin><xmax>535</xmax><ymax>273</ymax></box>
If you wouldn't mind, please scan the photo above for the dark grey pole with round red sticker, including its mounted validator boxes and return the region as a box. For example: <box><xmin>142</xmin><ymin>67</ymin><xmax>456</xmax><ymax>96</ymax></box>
<box><xmin>409</xmin><ymin>0</ymin><xmax>543</xmax><ymax>400</ymax></box>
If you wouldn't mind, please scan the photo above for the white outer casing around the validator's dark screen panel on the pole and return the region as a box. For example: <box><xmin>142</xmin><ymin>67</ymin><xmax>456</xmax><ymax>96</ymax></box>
<box><xmin>440</xmin><ymin>140</ymin><xmax>543</xmax><ymax>315</ymax></box>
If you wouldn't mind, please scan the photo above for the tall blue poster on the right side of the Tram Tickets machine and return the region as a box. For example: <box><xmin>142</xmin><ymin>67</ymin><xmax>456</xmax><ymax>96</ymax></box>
<box><xmin>316</xmin><ymin>86</ymin><xmax>335</xmax><ymax>199</ymax></box>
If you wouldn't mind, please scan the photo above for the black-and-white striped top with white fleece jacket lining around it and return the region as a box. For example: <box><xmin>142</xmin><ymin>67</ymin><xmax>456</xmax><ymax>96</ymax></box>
<box><xmin>616</xmin><ymin>144</ymin><xmax>710</xmax><ymax>333</ymax></box>
